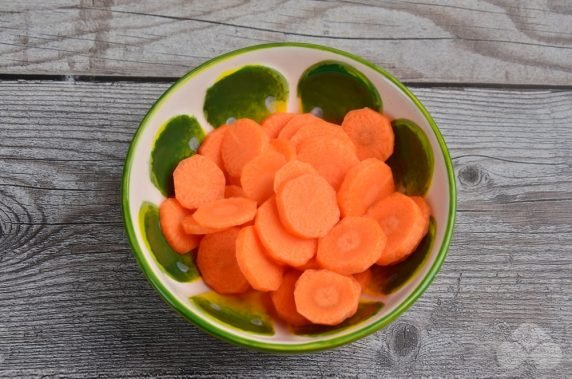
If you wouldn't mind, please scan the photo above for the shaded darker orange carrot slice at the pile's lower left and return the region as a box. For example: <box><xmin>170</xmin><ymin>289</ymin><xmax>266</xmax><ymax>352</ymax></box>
<box><xmin>197</xmin><ymin>228</ymin><xmax>250</xmax><ymax>294</ymax></box>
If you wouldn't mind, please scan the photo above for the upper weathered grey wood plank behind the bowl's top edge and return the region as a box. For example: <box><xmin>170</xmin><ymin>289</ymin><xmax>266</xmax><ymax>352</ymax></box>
<box><xmin>0</xmin><ymin>0</ymin><xmax>572</xmax><ymax>85</ymax></box>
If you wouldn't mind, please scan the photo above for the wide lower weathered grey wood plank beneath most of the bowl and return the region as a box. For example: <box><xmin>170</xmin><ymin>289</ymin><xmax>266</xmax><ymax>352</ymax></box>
<box><xmin>0</xmin><ymin>81</ymin><xmax>572</xmax><ymax>377</ymax></box>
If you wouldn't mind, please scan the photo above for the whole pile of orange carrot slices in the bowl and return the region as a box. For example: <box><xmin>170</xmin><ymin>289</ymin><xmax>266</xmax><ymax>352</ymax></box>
<box><xmin>159</xmin><ymin>108</ymin><xmax>431</xmax><ymax>326</ymax></box>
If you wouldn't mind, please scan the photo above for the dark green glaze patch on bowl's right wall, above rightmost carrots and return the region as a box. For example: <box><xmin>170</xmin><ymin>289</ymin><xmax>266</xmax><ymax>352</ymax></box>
<box><xmin>387</xmin><ymin>119</ymin><xmax>434</xmax><ymax>196</ymax></box>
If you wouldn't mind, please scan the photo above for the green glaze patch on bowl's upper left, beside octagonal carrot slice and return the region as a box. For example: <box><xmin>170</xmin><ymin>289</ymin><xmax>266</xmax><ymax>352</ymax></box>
<box><xmin>151</xmin><ymin>115</ymin><xmax>205</xmax><ymax>196</ymax></box>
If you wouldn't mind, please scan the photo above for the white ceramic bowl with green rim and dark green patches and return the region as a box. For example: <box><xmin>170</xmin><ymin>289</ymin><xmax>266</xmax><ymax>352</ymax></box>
<box><xmin>122</xmin><ymin>43</ymin><xmax>456</xmax><ymax>352</ymax></box>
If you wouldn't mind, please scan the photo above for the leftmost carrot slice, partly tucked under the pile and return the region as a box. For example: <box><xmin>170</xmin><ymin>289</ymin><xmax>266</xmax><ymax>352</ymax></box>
<box><xmin>159</xmin><ymin>197</ymin><xmax>199</xmax><ymax>254</ymax></box>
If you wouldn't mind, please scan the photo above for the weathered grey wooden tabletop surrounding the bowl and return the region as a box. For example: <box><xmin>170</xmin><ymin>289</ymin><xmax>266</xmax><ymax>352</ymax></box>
<box><xmin>0</xmin><ymin>0</ymin><xmax>572</xmax><ymax>378</ymax></box>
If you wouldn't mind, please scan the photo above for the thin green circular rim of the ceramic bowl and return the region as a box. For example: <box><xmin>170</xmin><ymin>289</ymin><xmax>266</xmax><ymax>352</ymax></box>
<box><xmin>121</xmin><ymin>42</ymin><xmax>457</xmax><ymax>353</ymax></box>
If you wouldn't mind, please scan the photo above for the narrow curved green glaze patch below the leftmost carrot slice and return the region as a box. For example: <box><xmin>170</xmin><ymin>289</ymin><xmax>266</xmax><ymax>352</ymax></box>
<box><xmin>139</xmin><ymin>203</ymin><xmax>199</xmax><ymax>282</ymax></box>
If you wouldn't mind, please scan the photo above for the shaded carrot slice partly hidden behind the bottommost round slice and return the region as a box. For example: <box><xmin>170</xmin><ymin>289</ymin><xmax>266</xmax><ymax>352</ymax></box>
<box><xmin>270</xmin><ymin>270</ymin><xmax>310</xmax><ymax>326</ymax></box>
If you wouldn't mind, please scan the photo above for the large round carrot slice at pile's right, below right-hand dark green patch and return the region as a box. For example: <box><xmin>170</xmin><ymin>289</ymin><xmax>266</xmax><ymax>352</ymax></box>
<box><xmin>367</xmin><ymin>192</ymin><xmax>426</xmax><ymax>266</ymax></box>
